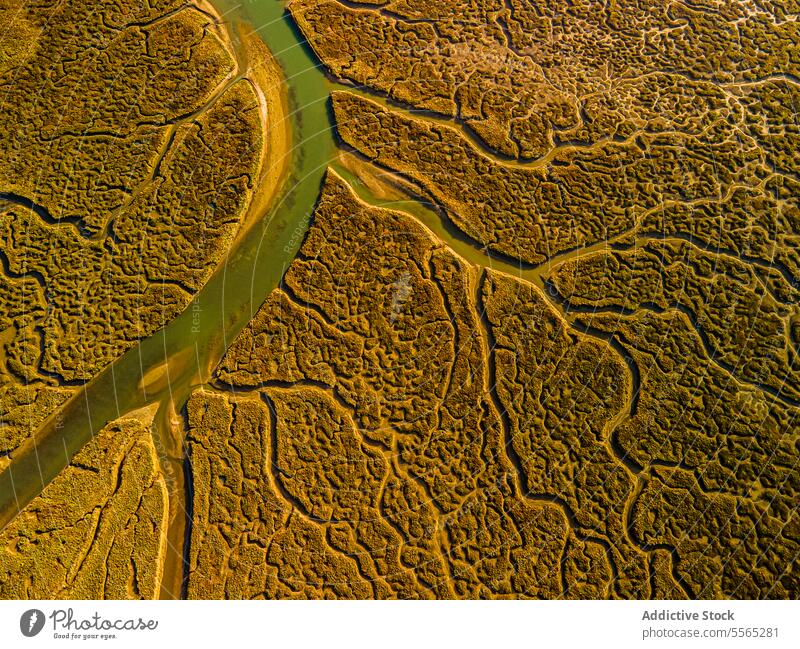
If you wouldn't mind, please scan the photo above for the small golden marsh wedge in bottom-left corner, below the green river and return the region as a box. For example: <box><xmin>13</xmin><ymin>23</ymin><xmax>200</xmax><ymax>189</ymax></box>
<box><xmin>0</xmin><ymin>418</ymin><xmax>168</xmax><ymax>599</ymax></box>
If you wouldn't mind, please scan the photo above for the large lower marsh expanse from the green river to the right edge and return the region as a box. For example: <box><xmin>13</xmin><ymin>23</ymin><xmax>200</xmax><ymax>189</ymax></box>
<box><xmin>188</xmin><ymin>172</ymin><xmax>797</xmax><ymax>598</ymax></box>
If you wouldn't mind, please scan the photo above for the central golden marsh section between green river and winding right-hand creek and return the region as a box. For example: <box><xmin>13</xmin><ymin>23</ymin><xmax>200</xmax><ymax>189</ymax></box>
<box><xmin>189</xmin><ymin>172</ymin><xmax>700</xmax><ymax>598</ymax></box>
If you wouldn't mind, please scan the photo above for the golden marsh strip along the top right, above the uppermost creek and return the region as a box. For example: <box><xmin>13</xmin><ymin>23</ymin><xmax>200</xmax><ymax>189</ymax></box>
<box><xmin>289</xmin><ymin>0</ymin><xmax>800</xmax><ymax>159</ymax></box>
